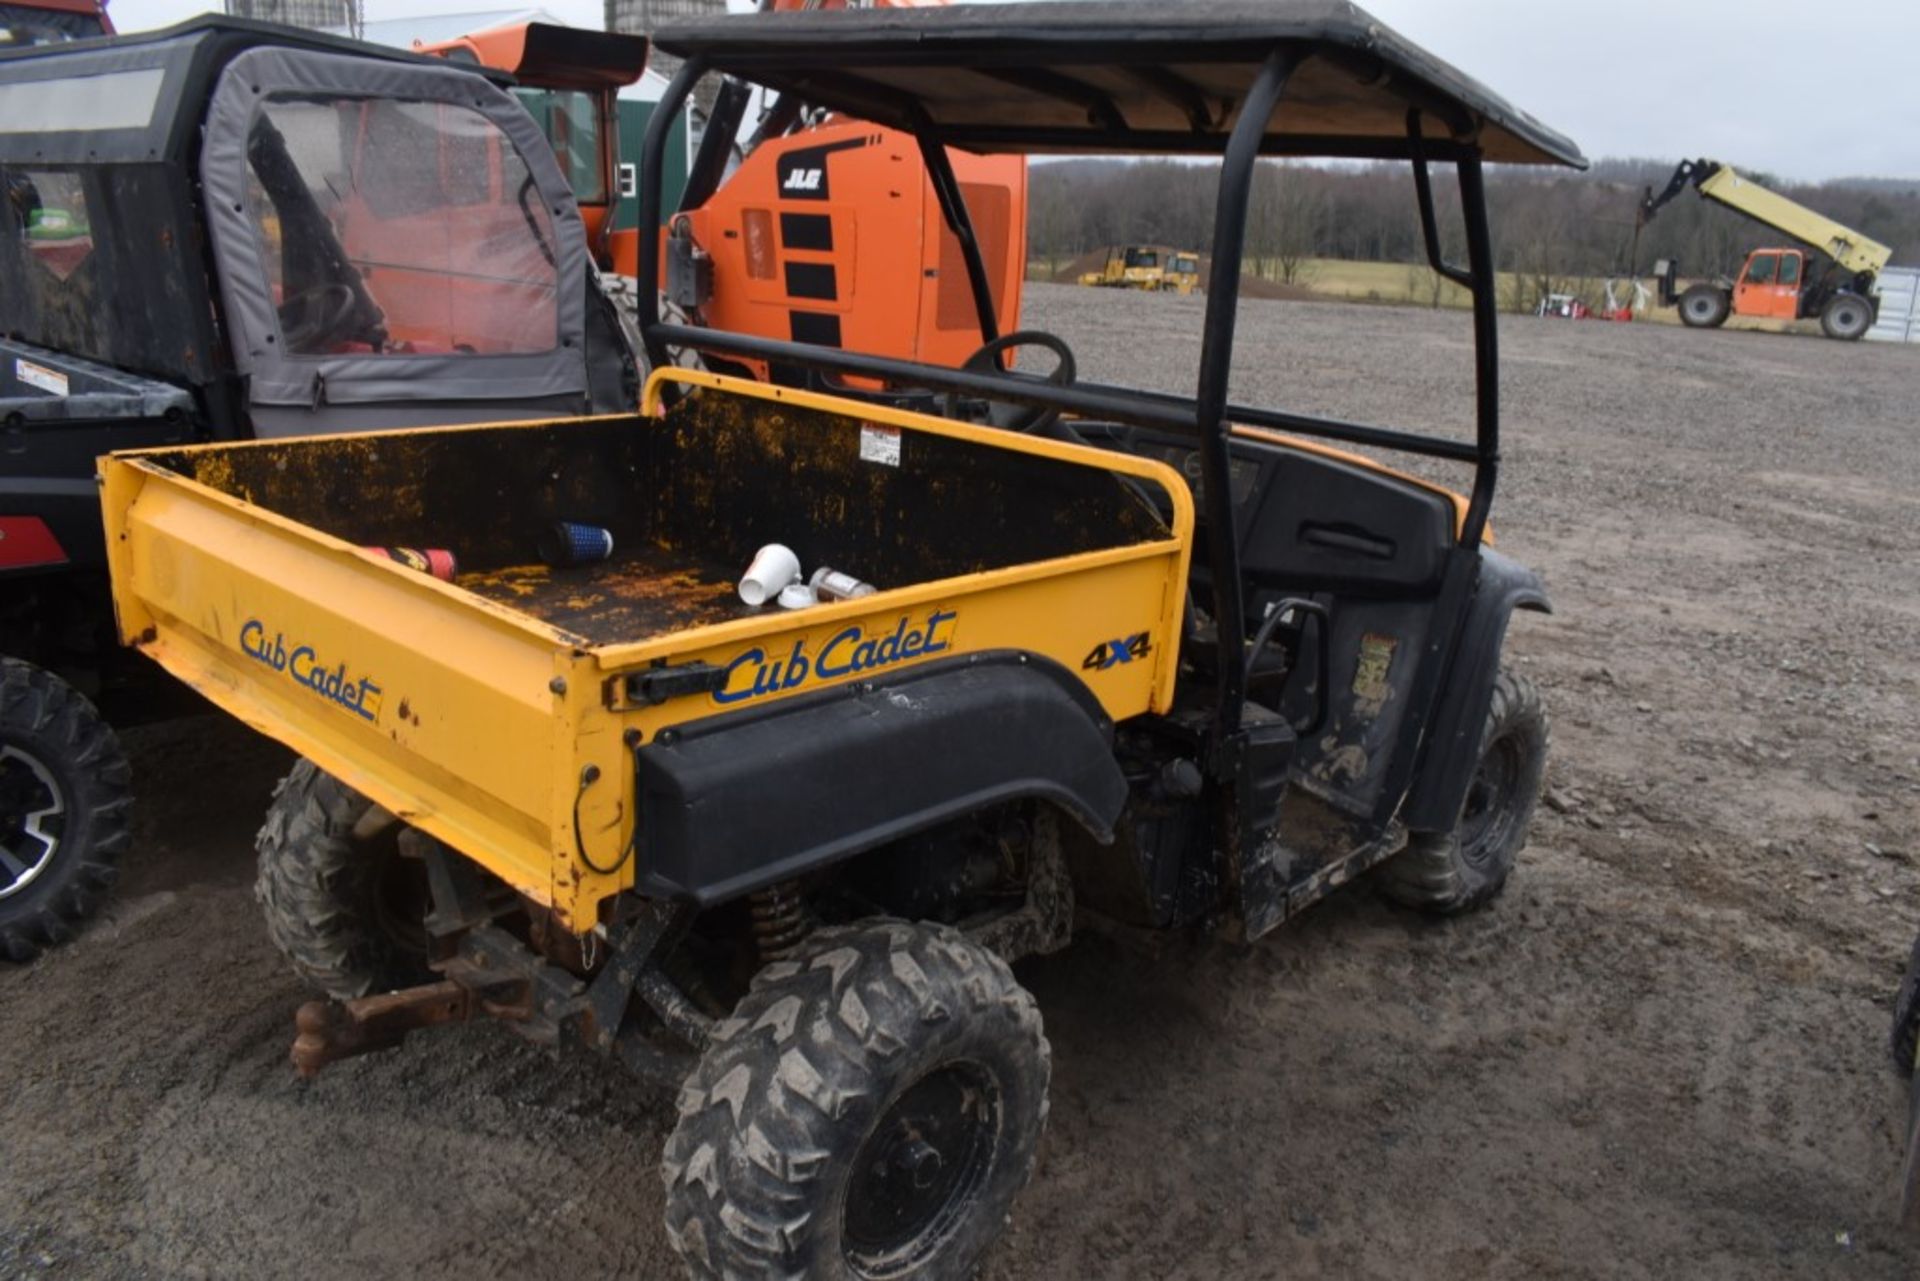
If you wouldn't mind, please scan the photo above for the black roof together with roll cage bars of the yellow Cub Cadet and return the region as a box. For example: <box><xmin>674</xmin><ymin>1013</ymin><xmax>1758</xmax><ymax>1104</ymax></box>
<box><xmin>639</xmin><ymin>0</ymin><xmax>1586</xmax><ymax>722</ymax></box>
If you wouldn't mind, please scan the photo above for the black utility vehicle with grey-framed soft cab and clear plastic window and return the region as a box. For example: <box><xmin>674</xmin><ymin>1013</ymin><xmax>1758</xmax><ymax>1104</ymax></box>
<box><xmin>0</xmin><ymin>17</ymin><xmax>637</xmax><ymax>960</ymax></box>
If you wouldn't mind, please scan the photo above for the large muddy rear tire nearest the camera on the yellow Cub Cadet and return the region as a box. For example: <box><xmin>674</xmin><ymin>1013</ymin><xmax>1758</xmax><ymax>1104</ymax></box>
<box><xmin>662</xmin><ymin>922</ymin><xmax>1048</xmax><ymax>1281</ymax></box>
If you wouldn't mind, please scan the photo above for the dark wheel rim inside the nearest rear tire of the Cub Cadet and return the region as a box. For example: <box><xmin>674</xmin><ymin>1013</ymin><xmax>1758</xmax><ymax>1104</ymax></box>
<box><xmin>843</xmin><ymin>1062</ymin><xmax>1002</xmax><ymax>1279</ymax></box>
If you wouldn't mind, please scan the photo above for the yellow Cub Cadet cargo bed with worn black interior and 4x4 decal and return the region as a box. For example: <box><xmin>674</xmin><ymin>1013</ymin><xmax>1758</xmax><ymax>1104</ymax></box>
<box><xmin>104</xmin><ymin>371</ymin><xmax>1192</xmax><ymax>930</ymax></box>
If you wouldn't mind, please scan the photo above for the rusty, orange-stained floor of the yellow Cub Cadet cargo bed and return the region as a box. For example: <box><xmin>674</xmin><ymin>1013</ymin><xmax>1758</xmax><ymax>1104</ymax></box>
<box><xmin>453</xmin><ymin>547</ymin><xmax>762</xmax><ymax>645</ymax></box>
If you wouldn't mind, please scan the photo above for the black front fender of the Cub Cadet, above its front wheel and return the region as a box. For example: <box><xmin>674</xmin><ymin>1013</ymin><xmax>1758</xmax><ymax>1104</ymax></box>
<box><xmin>1400</xmin><ymin>547</ymin><xmax>1553</xmax><ymax>832</ymax></box>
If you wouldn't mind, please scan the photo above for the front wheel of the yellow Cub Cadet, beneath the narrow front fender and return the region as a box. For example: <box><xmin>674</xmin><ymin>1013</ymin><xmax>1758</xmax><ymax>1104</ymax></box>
<box><xmin>1380</xmin><ymin>670</ymin><xmax>1548</xmax><ymax>916</ymax></box>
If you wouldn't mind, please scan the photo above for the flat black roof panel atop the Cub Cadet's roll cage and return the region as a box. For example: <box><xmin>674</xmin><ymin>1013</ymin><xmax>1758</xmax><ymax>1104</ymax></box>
<box><xmin>655</xmin><ymin>0</ymin><xmax>1586</xmax><ymax>167</ymax></box>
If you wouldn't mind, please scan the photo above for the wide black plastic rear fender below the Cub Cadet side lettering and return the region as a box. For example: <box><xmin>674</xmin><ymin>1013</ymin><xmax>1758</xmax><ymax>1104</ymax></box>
<box><xmin>634</xmin><ymin>651</ymin><xmax>1127</xmax><ymax>906</ymax></box>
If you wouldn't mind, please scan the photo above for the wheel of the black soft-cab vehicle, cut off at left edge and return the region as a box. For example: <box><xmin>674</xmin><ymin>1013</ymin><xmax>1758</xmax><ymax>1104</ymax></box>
<box><xmin>0</xmin><ymin>659</ymin><xmax>132</xmax><ymax>962</ymax></box>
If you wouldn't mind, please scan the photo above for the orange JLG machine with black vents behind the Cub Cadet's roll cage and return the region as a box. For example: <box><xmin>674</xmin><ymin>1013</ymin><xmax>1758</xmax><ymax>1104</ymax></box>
<box><xmin>417</xmin><ymin>0</ymin><xmax>1027</xmax><ymax>382</ymax></box>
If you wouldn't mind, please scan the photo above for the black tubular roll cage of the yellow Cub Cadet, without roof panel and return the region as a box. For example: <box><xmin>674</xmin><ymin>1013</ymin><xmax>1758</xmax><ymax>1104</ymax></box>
<box><xmin>639</xmin><ymin>40</ymin><xmax>1500</xmax><ymax>745</ymax></box>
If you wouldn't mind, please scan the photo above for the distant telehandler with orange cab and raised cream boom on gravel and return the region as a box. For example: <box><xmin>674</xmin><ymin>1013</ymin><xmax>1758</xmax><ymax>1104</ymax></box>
<box><xmin>1636</xmin><ymin>159</ymin><xmax>1893</xmax><ymax>342</ymax></box>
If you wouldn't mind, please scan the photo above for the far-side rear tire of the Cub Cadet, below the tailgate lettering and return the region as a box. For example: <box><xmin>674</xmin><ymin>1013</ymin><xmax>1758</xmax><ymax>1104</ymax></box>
<box><xmin>253</xmin><ymin>761</ymin><xmax>430</xmax><ymax>1001</ymax></box>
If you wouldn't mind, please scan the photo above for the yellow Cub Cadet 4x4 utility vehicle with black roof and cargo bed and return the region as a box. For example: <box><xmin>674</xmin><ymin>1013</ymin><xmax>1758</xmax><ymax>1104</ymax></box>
<box><xmin>104</xmin><ymin>0</ymin><xmax>1584</xmax><ymax>1279</ymax></box>
